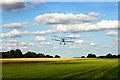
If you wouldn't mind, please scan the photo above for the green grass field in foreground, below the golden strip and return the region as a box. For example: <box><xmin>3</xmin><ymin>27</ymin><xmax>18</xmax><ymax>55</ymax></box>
<box><xmin>2</xmin><ymin>58</ymin><xmax>119</xmax><ymax>79</ymax></box>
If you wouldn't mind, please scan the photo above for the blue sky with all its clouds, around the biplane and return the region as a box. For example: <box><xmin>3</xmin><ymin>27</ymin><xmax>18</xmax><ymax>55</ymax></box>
<box><xmin>0</xmin><ymin>2</ymin><xmax>118</xmax><ymax>57</ymax></box>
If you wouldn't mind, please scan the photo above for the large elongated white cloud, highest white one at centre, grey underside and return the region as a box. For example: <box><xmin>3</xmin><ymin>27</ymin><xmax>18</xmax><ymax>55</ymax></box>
<box><xmin>35</xmin><ymin>13</ymin><xmax>97</xmax><ymax>24</ymax></box>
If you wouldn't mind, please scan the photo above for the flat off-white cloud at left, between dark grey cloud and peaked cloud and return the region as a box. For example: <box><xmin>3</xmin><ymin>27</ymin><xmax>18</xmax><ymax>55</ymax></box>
<box><xmin>2</xmin><ymin>22</ymin><xmax>28</xmax><ymax>29</ymax></box>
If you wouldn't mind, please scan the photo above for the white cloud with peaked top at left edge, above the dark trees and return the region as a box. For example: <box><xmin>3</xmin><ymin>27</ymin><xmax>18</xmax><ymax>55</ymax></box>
<box><xmin>0</xmin><ymin>29</ymin><xmax>29</xmax><ymax>38</ymax></box>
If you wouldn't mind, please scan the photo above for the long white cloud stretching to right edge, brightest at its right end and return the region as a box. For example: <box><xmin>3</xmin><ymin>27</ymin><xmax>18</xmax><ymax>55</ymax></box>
<box><xmin>52</xmin><ymin>20</ymin><xmax>118</xmax><ymax>32</ymax></box>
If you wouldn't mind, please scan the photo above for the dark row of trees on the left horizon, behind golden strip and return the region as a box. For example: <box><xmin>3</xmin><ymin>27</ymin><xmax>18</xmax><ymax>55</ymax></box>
<box><xmin>0</xmin><ymin>49</ymin><xmax>60</xmax><ymax>58</ymax></box>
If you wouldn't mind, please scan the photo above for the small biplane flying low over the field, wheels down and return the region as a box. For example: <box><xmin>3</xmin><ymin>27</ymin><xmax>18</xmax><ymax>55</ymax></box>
<box><xmin>52</xmin><ymin>36</ymin><xmax>75</xmax><ymax>45</ymax></box>
